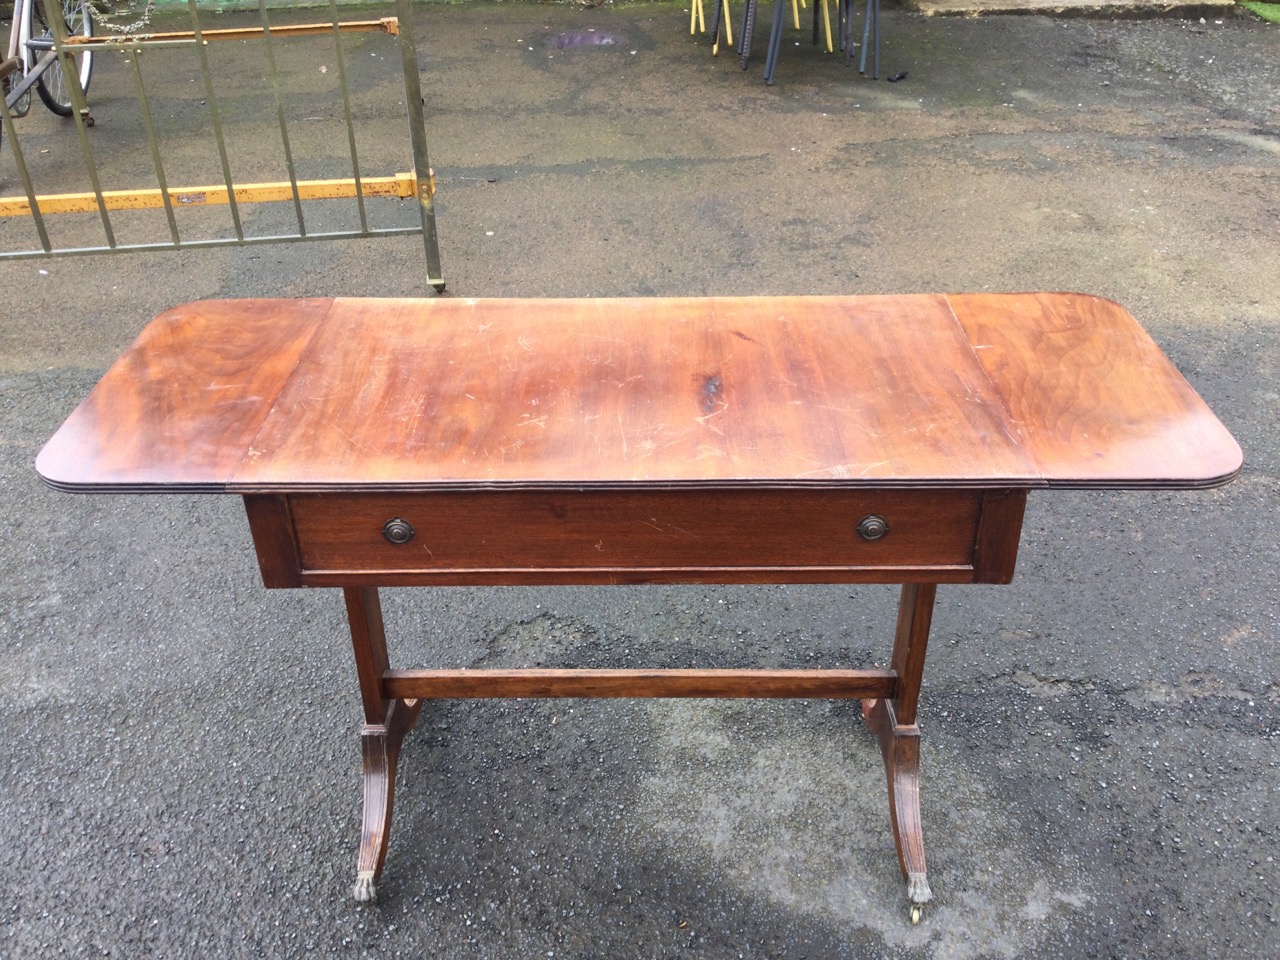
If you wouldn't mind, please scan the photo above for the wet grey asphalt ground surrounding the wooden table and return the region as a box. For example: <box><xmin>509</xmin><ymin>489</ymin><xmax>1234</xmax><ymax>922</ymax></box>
<box><xmin>0</xmin><ymin>4</ymin><xmax>1280</xmax><ymax>960</ymax></box>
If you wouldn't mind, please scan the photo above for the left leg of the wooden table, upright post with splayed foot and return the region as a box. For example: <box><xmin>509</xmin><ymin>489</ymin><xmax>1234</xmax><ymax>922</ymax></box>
<box><xmin>343</xmin><ymin>588</ymin><xmax>422</xmax><ymax>902</ymax></box>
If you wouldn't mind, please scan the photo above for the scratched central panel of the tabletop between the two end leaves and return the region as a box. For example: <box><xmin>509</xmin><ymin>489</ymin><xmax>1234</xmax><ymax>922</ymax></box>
<box><xmin>236</xmin><ymin>297</ymin><xmax>1036</xmax><ymax>489</ymax></box>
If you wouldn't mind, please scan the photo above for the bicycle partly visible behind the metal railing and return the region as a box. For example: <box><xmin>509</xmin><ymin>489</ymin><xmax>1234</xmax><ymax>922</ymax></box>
<box><xmin>0</xmin><ymin>0</ymin><xmax>93</xmax><ymax>128</ymax></box>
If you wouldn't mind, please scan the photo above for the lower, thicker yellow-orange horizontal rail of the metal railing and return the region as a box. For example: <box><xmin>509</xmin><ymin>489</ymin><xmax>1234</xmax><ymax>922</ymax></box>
<box><xmin>0</xmin><ymin>173</ymin><xmax>419</xmax><ymax>216</ymax></box>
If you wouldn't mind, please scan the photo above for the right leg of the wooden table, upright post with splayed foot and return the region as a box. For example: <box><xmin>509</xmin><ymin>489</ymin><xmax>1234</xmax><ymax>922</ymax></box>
<box><xmin>863</xmin><ymin>584</ymin><xmax>937</xmax><ymax>922</ymax></box>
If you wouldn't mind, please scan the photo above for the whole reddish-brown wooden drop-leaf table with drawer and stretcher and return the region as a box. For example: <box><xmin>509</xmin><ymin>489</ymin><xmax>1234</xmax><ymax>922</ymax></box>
<box><xmin>37</xmin><ymin>294</ymin><xmax>1242</xmax><ymax>919</ymax></box>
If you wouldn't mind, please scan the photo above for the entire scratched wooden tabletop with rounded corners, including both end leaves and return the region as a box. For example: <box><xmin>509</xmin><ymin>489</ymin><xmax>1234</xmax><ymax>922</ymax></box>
<box><xmin>36</xmin><ymin>293</ymin><xmax>1242</xmax><ymax>493</ymax></box>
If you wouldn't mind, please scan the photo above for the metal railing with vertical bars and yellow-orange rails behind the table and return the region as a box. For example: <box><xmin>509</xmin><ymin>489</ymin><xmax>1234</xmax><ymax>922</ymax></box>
<box><xmin>0</xmin><ymin>0</ymin><xmax>444</xmax><ymax>291</ymax></box>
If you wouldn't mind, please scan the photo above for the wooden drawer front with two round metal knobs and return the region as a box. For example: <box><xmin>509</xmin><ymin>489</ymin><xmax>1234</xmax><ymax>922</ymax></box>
<box><xmin>270</xmin><ymin>490</ymin><xmax>983</xmax><ymax>584</ymax></box>
